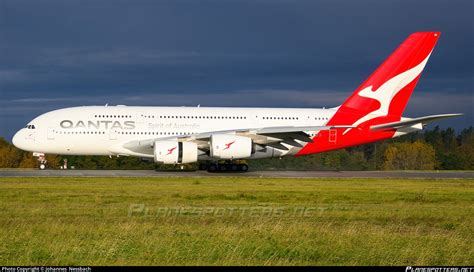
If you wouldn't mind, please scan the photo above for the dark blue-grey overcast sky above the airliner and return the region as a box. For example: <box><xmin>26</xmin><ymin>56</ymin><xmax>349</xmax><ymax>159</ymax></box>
<box><xmin>0</xmin><ymin>0</ymin><xmax>474</xmax><ymax>140</ymax></box>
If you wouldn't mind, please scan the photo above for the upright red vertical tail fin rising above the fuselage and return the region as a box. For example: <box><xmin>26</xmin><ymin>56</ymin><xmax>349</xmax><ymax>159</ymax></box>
<box><xmin>332</xmin><ymin>32</ymin><xmax>440</xmax><ymax>124</ymax></box>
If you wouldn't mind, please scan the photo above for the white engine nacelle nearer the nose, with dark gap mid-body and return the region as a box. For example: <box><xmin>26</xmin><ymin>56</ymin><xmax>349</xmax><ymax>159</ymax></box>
<box><xmin>153</xmin><ymin>141</ymin><xmax>198</xmax><ymax>164</ymax></box>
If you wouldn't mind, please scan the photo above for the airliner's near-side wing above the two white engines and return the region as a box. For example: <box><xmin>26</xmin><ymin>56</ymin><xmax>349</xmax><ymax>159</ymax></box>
<box><xmin>115</xmin><ymin>125</ymin><xmax>355</xmax><ymax>157</ymax></box>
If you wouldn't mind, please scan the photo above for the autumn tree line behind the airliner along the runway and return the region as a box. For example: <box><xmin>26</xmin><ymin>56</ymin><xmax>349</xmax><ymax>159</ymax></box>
<box><xmin>0</xmin><ymin>126</ymin><xmax>474</xmax><ymax>170</ymax></box>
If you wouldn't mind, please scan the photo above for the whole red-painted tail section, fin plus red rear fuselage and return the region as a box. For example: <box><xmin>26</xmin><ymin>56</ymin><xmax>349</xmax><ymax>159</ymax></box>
<box><xmin>298</xmin><ymin>32</ymin><xmax>440</xmax><ymax>155</ymax></box>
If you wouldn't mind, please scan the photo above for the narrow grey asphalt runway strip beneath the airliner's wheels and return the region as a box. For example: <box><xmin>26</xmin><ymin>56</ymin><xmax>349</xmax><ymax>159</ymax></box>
<box><xmin>0</xmin><ymin>169</ymin><xmax>474</xmax><ymax>179</ymax></box>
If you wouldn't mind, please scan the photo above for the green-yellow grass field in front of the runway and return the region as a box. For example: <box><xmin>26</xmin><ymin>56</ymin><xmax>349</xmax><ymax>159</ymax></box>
<box><xmin>0</xmin><ymin>177</ymin><xmax>474</xmax><ymax>265</ymax></box>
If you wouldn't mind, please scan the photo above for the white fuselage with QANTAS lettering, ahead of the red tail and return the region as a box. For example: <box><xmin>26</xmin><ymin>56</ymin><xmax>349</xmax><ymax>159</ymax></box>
<box><xmin>13</xmin><ymin>106</ymin><xmax>336</xmax><ymax>158</ymax></box>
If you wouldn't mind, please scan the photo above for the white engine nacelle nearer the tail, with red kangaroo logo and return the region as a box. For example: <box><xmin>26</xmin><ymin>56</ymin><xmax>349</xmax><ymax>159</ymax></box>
<box><xmin>210</xmin><ymin>134</ymin><xmax>252</xmax><ymax>159</ymax></box>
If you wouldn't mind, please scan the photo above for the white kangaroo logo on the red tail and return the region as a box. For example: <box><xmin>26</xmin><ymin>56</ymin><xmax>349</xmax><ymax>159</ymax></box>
<box><xmin>342</xmin><ymin>52</ymin><xmax>431</xmax><ymax>135</ymax></box>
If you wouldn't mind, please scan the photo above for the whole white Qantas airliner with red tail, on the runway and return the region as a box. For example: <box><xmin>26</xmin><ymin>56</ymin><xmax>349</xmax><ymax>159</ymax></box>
<box><xmin>12</xmin><ymin>32</ymin><xmax>462</xmax><ymax>172</ymax></box>
